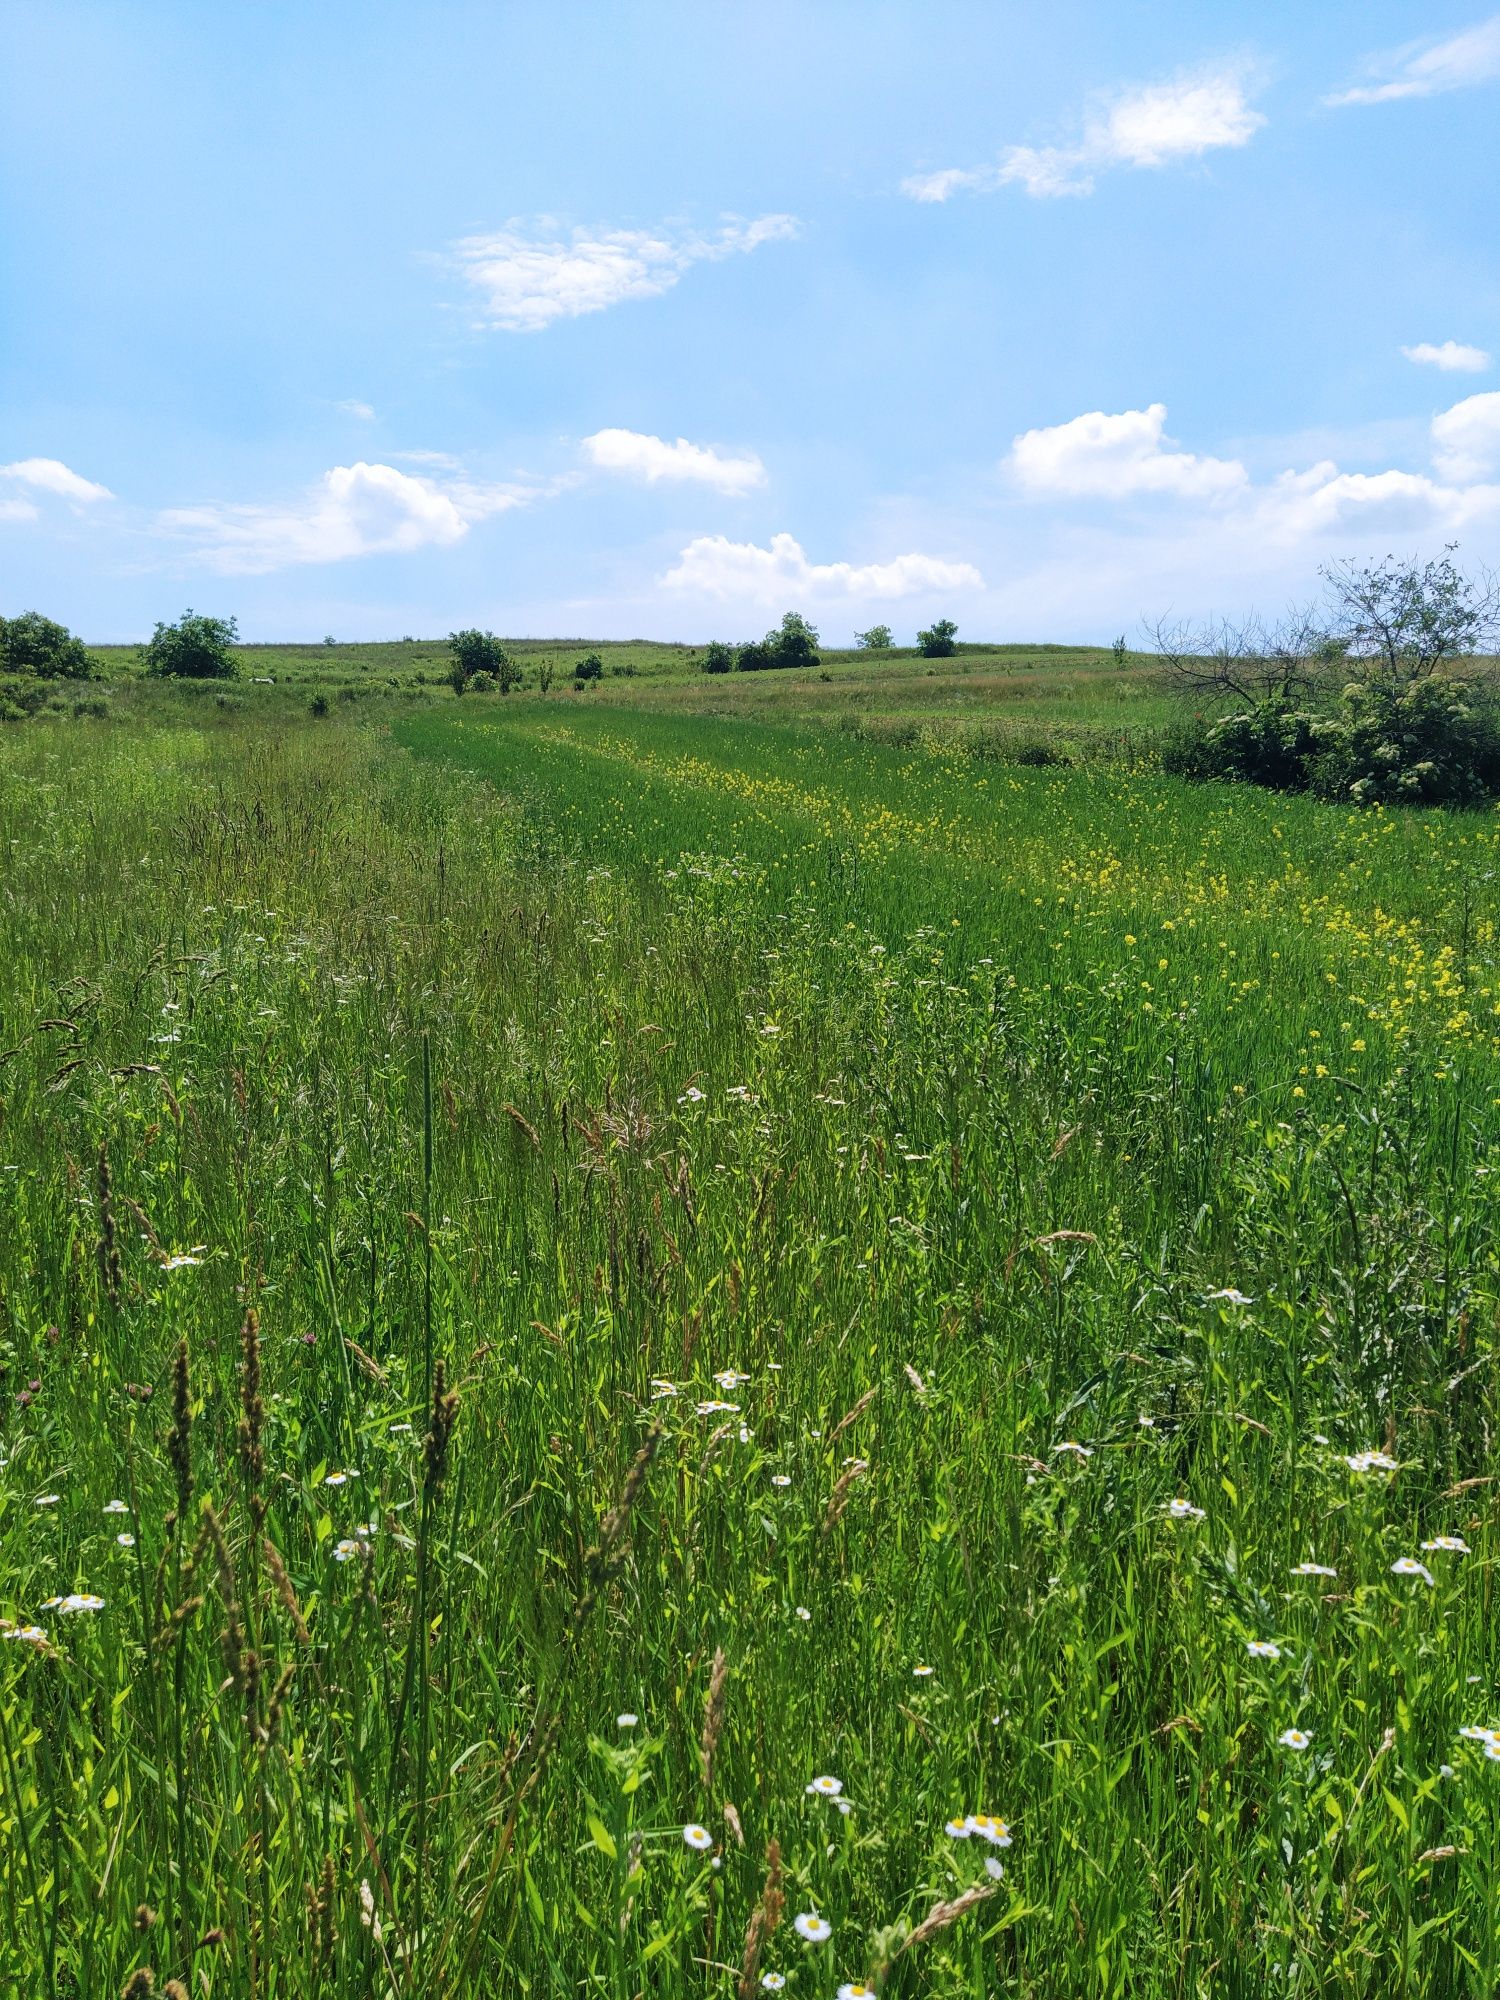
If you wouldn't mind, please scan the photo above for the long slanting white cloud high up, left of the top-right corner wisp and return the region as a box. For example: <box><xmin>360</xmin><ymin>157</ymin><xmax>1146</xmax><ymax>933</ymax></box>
<box><xmin>902</xmin><ymin>66</ymin><xmax>1266</xmax><ymax>202</ymax></box>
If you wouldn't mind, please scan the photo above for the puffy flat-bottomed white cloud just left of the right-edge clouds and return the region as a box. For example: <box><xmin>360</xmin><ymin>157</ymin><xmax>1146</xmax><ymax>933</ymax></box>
<box><xmin>1008</xmin><ymin>402</ymin><xmax>1248</xmax><ymax>500</ymax></box>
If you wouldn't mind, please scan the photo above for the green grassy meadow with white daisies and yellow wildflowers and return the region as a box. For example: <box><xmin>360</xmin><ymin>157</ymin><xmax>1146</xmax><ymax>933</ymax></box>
<box><xmin>0</xmin><ymin>676</ymin><xmax>1500</xmax><ymax>2000</ymax></box>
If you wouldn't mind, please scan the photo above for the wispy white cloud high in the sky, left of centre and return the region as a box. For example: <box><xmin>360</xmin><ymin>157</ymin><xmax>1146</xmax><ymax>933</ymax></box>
<box><xmin>452</xmin><ymin>216</ymin><xmax>798</xmax><ymax>334</ymax></box>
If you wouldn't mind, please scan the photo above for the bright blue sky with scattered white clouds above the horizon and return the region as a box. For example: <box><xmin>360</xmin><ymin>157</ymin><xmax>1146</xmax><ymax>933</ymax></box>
<box><xmin>0</xmin><ymin>0</ymin><xmax>1500</xmax><ymax>642</ymax></box>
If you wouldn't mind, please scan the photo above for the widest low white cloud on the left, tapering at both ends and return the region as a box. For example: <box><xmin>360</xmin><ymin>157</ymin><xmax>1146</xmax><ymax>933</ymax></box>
<box><xmin>156</xmin><ymin>460</ymin><xmax>528</xmax><ymax>576</ymax></box>
